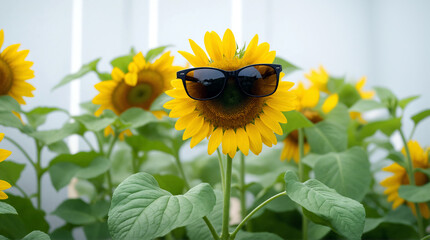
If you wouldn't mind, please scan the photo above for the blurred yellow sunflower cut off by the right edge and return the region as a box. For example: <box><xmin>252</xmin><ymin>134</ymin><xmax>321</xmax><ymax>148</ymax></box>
<box><xmin>381</xmin><ymin>140</ymin><xmax>430</xmax><ymax>219</ymax></box>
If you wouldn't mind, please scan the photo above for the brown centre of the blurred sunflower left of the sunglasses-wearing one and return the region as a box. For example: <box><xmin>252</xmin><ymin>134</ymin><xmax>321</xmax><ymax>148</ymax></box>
<box><xmin>112</xmin><ymin>70</ymin><xmax>164</xmax><ymax>113</ymax></box>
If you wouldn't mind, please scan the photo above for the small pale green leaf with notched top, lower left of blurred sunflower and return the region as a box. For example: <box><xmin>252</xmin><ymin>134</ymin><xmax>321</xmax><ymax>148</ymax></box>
<box><xmin>73</xmin><ymin>110</ymin><xmax>117</xmax><ymax>132</ymax></box>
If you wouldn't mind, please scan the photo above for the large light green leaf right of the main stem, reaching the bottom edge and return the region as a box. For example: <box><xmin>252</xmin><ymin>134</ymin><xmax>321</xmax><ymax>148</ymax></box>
<box><xmin>285</xmin><ymin>171</ymin><xmax>365</xmax><ymax>239</ymax></box>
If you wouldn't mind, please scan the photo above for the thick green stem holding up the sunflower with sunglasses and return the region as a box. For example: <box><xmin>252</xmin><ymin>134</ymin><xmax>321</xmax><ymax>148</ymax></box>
<box><xmin>221</xmin><ymin>154</ymin><xmax>233</xmax><ymax>240</ymax></box>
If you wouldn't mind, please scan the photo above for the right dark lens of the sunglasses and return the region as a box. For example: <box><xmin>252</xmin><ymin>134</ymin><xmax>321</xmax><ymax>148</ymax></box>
<box><xmin>238</xmin><ymin>65</ymin><xmax>278</xmax><ymax>97</ymax></box>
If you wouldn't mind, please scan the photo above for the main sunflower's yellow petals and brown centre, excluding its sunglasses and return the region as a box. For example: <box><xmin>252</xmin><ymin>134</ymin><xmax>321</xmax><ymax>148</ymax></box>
<box><xmin>164</xmin><ymin>29</ymin><xmax>296</xmax><ymax>158</ymax></box>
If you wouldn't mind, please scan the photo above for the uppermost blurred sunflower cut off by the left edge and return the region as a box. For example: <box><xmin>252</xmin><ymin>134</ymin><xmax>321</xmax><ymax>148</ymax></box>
<box><xmin>0</xmin><ymin>29</ymin><xmax>36</xmax><ymax>104</ymax></box>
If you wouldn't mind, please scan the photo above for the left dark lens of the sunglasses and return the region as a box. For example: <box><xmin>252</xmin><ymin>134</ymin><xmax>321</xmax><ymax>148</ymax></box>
<box><xmin>185</xmin><ymin>69</ymin><xmax>225</xmax><ymax>100</ymax></box>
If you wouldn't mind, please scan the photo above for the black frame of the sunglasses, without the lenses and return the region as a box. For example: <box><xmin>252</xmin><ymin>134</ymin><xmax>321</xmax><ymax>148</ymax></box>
<box><xmin>176</xmin><ymin>63</ymin><xmax>282</xmax><ymax>101</ymax></box>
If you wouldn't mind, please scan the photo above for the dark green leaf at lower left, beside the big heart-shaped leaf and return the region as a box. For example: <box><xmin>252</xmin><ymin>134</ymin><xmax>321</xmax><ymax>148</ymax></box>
<box><xmin>52</xmin><ymin>199</ymin><xmax>97</xmax><ymax>225</ymax></box>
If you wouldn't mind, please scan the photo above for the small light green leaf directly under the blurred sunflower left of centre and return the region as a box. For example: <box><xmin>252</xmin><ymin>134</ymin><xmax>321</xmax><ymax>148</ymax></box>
<box><xmin>119</xmin><ymin>108</ymin><xmax>157</xmax><ymax>129</ymax></box>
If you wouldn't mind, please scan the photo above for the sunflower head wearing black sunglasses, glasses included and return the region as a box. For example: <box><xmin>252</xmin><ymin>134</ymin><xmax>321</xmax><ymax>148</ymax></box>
<box><xmin>164</xmin><ymin>29</ymin><xmax>296</xmax><ymax>158</ymax></box>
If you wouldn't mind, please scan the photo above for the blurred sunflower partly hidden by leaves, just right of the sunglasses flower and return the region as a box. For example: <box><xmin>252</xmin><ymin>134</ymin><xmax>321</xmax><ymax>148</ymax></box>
<box><xmin>281</xmin><ymin>82</ymin><xmax>339</xmax><ymax>163</ymax></box>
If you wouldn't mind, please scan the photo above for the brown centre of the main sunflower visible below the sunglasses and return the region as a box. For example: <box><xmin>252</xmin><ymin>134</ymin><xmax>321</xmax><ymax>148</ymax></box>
<box><xmin>197</xmin><ymin>79</ymin><xmax>264</xmax><ymax>129</ymax></box>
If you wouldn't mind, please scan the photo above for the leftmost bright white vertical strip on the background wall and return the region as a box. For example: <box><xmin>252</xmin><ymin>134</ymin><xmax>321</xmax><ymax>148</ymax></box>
<box><xmin>68</xmin><ymin>0</ymin><xmax>82</xmax><ymax>156</ymax></box>
